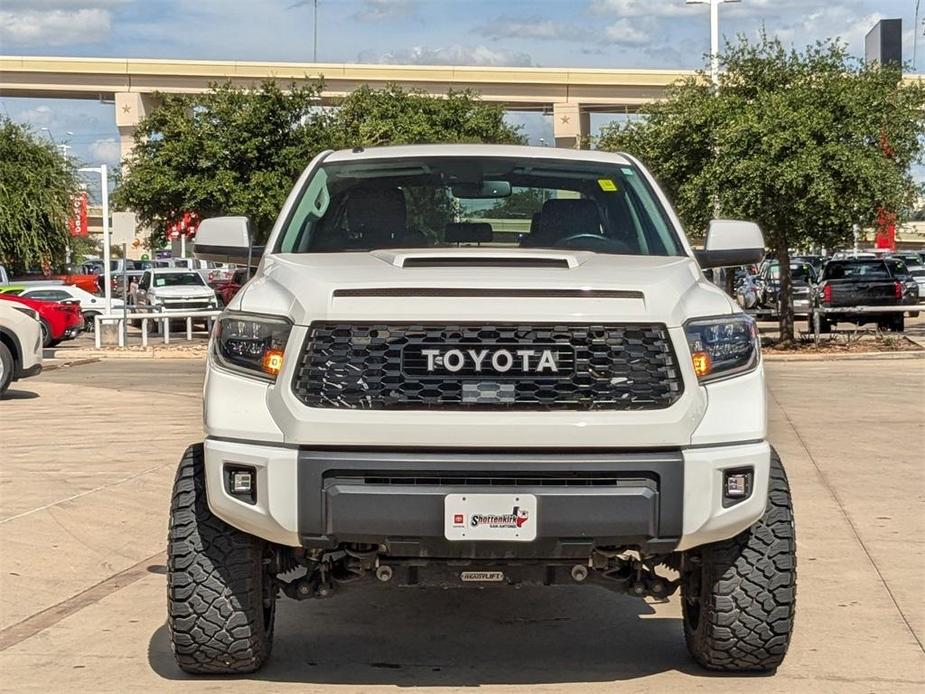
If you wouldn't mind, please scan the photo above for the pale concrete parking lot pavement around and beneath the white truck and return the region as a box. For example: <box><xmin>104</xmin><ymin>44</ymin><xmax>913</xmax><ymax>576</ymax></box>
<box><xmin>0</xmin><ymin>359</ymin><xmax>925</xmax><ymax>692</ymax></box>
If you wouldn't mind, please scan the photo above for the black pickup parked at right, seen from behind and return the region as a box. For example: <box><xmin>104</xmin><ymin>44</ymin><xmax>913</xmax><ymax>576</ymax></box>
<box><xmin>809</xmin><ymin>258</ymin><xmax>919</xmax><ymax>333</ymax></box>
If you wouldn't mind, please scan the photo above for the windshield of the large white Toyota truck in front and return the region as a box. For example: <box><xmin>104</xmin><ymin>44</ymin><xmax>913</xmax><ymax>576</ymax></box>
<box><xmin>276</xmin><ymin>157</ymin><xmax>684</xmax><ymax>256</ymax></box>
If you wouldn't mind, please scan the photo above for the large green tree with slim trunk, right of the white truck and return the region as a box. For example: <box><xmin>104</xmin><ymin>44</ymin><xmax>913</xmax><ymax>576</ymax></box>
<box><xmin>599</xmin><ymin>36</ymin><xmax>925</xmax><ymax>344</ymax></box>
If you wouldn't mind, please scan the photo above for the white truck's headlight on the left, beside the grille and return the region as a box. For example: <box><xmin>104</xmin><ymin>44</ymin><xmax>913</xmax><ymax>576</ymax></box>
<box><xmin>213</xmin><ymin>312</ymin><xmax>292</xmax><ymax>381</ymax></box>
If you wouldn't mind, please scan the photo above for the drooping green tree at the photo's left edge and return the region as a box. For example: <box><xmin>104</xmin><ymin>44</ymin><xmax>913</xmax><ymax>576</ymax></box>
<box><xmin>0</xmin><ymin>118</ymin><xmax>78</xmax><ymax>271</ymax></box>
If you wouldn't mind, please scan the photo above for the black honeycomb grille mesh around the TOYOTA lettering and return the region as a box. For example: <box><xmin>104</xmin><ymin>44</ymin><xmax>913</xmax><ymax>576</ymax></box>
<box><xmin>293</xmin><ymin>322</ymin><xmax>683</xmax><ymax>410</ymax></box>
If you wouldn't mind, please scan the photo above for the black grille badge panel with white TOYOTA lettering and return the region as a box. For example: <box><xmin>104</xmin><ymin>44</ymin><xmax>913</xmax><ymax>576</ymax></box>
<box><xmin>402</xmin><ymin>344</ymin><xmax>575</xmax><ymax>378</ymax></box>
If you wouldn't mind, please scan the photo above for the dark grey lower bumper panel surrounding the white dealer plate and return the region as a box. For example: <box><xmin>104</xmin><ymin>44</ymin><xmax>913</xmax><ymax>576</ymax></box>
<box><xmin>298</xmin><ymin>450</ymin><xmax>684</xmax><ymax>558</ymax></box>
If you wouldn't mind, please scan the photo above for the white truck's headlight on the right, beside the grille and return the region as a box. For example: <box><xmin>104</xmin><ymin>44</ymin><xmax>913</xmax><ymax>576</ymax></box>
<box><xmin>684</xmin><ymin>315</ymin><xmax>761</xmax><ymax>383</ymax></box>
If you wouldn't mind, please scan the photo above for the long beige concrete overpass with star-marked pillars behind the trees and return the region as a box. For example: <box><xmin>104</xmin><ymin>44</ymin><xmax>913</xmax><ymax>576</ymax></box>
<box><xmin>0</xmin><ymin>56</ymin><xmax>694</xmax><ymax>158</ymax></box>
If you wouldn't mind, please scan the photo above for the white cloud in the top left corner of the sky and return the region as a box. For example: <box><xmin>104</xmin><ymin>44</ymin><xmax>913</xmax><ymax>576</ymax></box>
<box><xmin>0</xmin><ymin>0</ymin><xmax>118</xmax><ymax>46</ymax></box>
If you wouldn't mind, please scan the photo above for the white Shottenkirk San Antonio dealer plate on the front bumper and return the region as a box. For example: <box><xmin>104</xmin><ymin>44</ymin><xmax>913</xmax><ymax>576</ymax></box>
<box><xmin>443</xmin><ymin>494</ymin><xmax>537</xmax><ymax>542</ymax></box>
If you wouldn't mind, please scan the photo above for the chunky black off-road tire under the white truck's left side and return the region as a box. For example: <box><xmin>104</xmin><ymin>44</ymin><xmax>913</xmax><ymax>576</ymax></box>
<box><xmin>167</xmin><ymin>444</ymin><xmax>277</xmax><ymax>674</ymax></box>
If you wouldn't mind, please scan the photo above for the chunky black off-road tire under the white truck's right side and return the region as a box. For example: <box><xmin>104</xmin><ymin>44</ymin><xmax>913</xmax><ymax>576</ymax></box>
<box><xmin>681</xmin><ymin>451</ymin><xmax>796</xmax><ymax>672</ymax></box>
